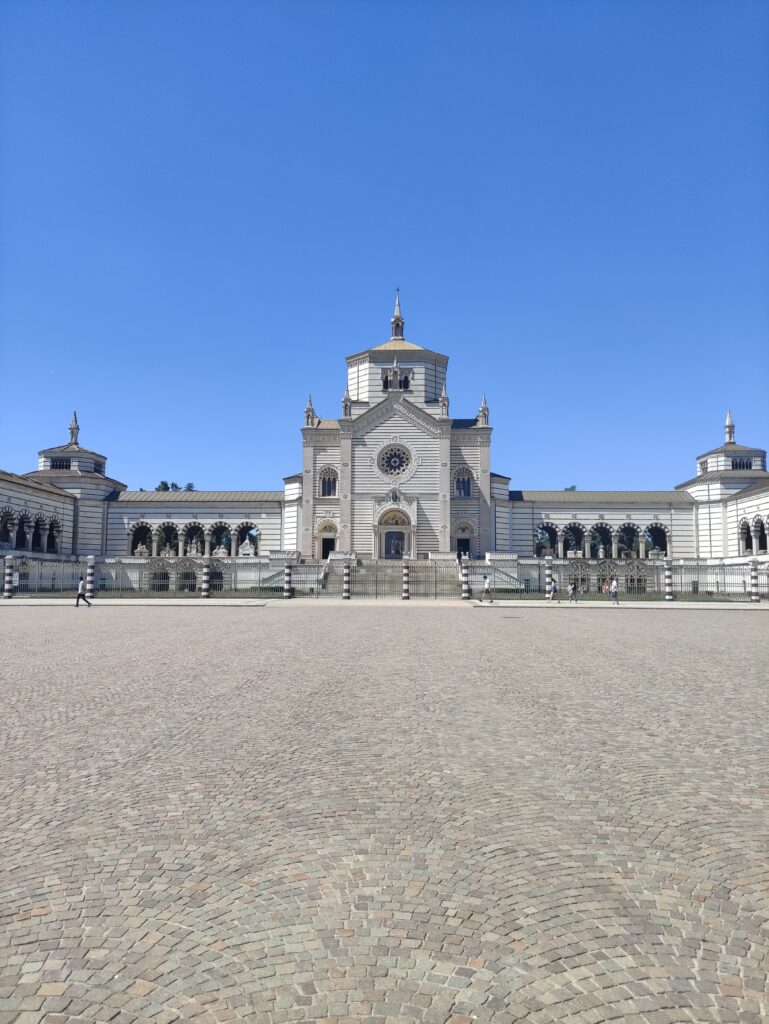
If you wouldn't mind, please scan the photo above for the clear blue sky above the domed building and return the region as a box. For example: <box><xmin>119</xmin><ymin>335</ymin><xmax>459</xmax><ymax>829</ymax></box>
<box><xmin>0</xmin><ymin>0</ymin><xmax>769</xmax><ymax>489</ymax></box>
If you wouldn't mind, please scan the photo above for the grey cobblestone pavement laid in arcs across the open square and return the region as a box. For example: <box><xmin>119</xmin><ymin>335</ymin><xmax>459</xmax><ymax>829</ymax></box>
<box><xmin>0</xmin><ymin>602</ymin><xmax>769</xmax><ymax>1024</ymax></box>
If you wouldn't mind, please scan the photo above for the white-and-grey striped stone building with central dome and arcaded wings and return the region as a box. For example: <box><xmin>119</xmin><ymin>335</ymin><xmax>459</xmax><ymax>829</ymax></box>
<box><xmin>0</xmin><ymin>300</ymin><xmax>769</xmax><ymax>561</ymax></box>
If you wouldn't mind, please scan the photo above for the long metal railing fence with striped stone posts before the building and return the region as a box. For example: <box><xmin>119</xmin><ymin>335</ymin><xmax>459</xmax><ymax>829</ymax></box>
<box><xmin>4</xmin><ymin>556</ymin><xmax>769</xmax><ymax>602</ymax></box>
